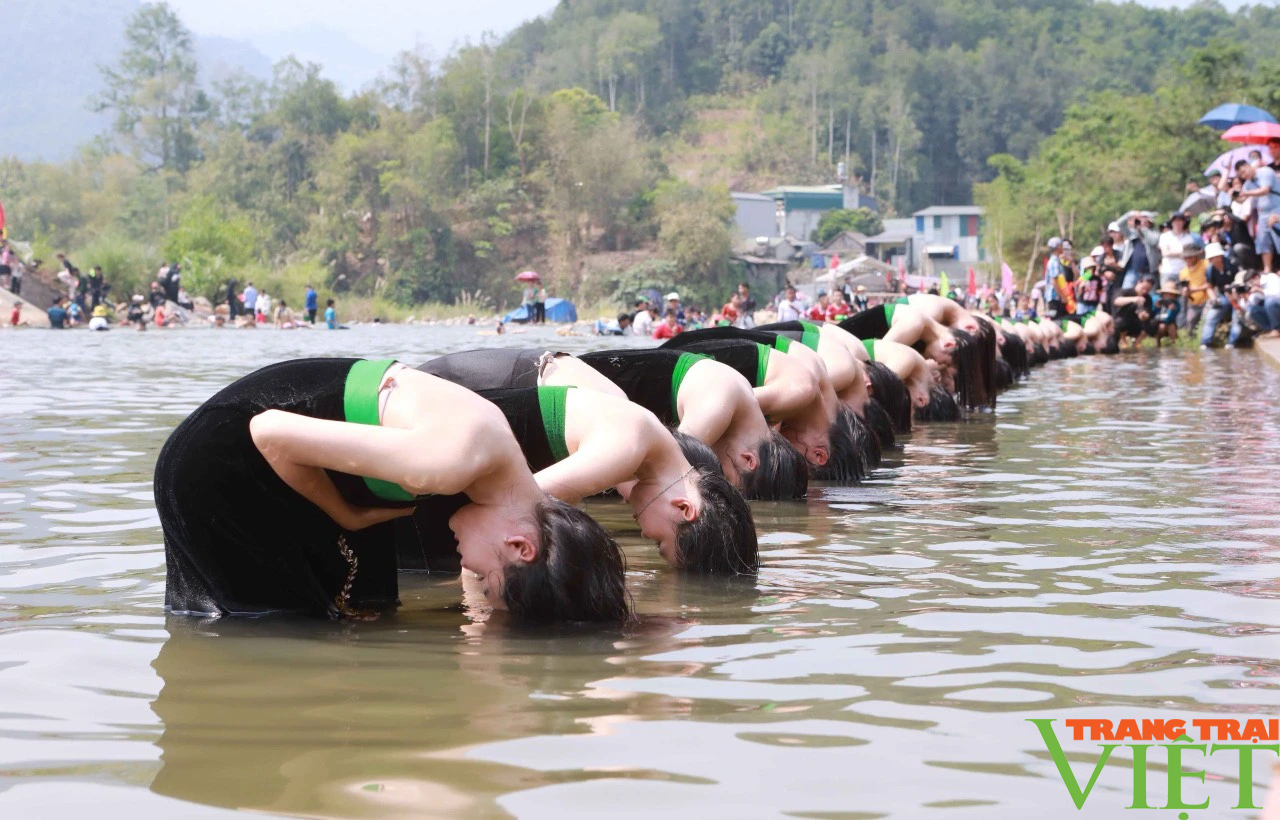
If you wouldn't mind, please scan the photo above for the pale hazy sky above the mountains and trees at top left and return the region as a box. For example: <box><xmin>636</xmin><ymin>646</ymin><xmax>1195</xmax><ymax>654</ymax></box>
<box><xmin>169</xmin><ymin>0</ymin><xmax>556</xmax><ymax>56</ymax></box>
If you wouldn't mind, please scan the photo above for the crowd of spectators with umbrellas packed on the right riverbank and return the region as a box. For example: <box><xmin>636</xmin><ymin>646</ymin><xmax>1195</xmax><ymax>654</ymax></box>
<box><xmin>1001</xmin><ymin>133</ymin><xmax>1280</xmax><ymax>348</ymax></box>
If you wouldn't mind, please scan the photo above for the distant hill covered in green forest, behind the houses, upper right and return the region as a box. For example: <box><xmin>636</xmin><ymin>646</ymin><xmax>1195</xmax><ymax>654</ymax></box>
<box><xmin>503</xmin><ymin>0</ymin><xmax>1280</xmax><ymax>211</ymax></box>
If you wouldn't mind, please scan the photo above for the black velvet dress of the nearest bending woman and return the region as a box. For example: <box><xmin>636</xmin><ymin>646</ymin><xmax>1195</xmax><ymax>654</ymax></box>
<box><xmin>155</xmin><ymin>358</ymin><xmax>412</xmax><ymax>617</ymax></box>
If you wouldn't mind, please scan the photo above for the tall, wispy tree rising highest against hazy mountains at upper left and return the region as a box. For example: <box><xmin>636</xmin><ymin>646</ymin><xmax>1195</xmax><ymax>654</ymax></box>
<box><xmin>91</xmin><ymin>3</ymin><xmax>211</xmax><ymax>173</ymax></box>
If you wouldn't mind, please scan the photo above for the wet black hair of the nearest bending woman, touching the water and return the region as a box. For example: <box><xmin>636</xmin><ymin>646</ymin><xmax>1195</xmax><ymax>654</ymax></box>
<box><xmin>502</xmin><ymin>496</ymin><xmax>631</xmax><ymax>623</ymax></box>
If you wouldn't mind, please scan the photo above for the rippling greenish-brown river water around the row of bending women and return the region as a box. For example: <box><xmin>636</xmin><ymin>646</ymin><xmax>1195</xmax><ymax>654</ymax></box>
<box><xmin>0</xmin><ymin>326</ymin><xmax>1280</xmax><ymax>819</ymax></box>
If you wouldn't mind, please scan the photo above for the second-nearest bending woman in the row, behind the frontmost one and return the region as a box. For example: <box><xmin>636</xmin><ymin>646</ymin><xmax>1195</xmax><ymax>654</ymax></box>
<box><xmin>417</xmin><ymin>349</ymin><xmax>759</xmax><ymax>574</ymax></box>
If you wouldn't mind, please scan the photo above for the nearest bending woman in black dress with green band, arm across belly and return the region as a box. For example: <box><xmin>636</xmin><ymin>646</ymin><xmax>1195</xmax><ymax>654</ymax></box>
<box><xmin>155</xmin><ymin>358</ymin><xmax>628</xmax><ymax>622</ymax></box>
